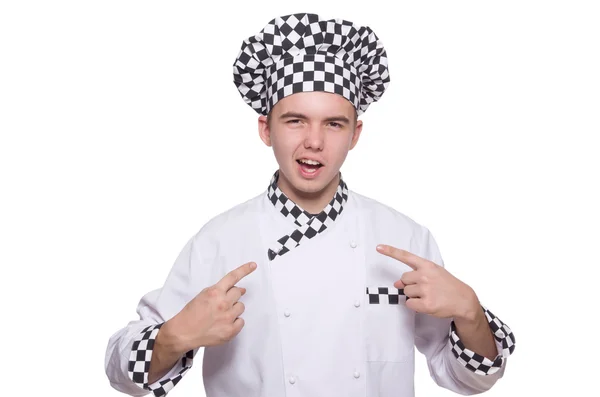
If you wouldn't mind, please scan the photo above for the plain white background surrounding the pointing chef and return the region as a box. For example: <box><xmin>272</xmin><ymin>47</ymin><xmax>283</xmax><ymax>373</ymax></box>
<box><xmin>0</xmin><ymin>0</ymin><xmax>600</xmax><ymax>397</ymax></box>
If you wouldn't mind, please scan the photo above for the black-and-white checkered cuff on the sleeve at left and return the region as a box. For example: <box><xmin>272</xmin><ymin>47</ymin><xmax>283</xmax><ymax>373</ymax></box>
<box><xmin>129</xmin><ymin>323</ymin><xmax>194</xmax><ymax>397</ymax></box>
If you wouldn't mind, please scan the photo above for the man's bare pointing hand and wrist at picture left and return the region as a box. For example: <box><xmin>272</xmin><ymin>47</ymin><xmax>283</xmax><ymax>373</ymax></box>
<box><xmin>157</xmin><ymin>262</ymin><xmax>256</xmax><ymax>354</ymax></box>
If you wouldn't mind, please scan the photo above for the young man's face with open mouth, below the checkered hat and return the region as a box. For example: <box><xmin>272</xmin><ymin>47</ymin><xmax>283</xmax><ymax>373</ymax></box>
<box><xmin>259</xmin><ymin>92</ymin><xmax>362</xmax><ymax>194</ymax></box>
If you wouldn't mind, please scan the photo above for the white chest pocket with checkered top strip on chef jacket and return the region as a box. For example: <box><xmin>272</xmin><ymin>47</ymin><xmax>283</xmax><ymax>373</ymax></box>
<box><xmin>365</xmin><ymin>286</ymin><xmax>414</xmax><ymax>362</ymax></box>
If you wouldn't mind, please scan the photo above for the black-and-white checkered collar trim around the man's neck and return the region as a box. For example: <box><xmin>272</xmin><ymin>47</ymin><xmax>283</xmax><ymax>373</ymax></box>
<box><xmin>267</xmin><ymin>170</ymin><xmax>348</xmax><ymax>261</ymax></box>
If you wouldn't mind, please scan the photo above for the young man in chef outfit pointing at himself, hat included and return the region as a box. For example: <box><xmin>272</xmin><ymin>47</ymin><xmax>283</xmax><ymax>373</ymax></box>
<box><xmin>106</xmin><ymin>14</ymin><xmax>515</xmax><ymax>397</ymax></box>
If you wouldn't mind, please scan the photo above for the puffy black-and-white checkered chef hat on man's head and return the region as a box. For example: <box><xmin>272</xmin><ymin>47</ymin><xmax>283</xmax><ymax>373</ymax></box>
<box><xmin>233</xmin><ymin>14</ymin><xmax>390</xmax><ymax>115</ymax></box>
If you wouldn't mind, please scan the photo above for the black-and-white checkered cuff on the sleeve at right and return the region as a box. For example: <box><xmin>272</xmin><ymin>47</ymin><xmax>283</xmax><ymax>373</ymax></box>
<box><xmin>450</xmin><ymin>306</ymin><xmax>515</xmax><ymax>375</ymax></box>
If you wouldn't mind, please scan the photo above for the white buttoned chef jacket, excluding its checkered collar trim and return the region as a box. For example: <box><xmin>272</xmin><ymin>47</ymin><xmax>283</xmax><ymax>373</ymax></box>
<box><xmin>105</xmin><ymin>179</ymin><xmax>514</xmax><ymax>397</ymax></box>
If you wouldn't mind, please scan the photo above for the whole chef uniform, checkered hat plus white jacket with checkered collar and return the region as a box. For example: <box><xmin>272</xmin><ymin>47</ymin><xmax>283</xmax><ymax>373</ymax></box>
<box><xmin>105</xmin><ymin>14</ymin><xmax>515</xmax><ymax>397</ymax></box>
